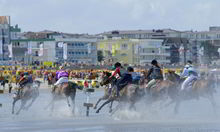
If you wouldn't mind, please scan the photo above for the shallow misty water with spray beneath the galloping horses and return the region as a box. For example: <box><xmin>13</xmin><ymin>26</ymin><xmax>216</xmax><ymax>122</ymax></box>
<box><xmin>0</xmin><ymin>84</ymin><xmax>220</xmax><ymax>132</ymax></box>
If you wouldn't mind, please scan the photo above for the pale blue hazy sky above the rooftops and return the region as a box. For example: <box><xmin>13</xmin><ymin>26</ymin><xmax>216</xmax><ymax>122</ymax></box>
<box><xmin>0</xmin><ymin>0</ymin><xmax>220</xmax><ymax>34</ymax></box>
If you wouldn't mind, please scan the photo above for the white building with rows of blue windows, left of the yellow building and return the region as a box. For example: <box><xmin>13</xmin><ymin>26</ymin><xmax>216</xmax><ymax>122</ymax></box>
<box><xmin>54</xmin><ymin>38</ymin><xmax>98</xmax><ymax>64</ymax></box>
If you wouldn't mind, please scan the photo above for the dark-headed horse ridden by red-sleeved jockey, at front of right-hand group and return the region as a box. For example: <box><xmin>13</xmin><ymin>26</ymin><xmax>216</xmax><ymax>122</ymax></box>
<box><xmin>94</xmin><ymin>72</ymin><xmax>116</xmax><ymax>112</ymax></box>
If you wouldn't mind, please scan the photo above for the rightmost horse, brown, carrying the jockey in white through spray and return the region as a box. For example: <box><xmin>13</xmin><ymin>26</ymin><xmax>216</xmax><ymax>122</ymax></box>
<box><xmin>166</xmin><ymin>71</ymin><xmax>216</xmax><ymax>114</ymax></box>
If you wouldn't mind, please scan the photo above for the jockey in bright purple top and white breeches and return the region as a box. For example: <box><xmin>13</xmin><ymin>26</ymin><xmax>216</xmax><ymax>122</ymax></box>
<box><xmin>54</xmin><ymin>66</ymin><xmax>69</xmax><ymax>86</ymax></box>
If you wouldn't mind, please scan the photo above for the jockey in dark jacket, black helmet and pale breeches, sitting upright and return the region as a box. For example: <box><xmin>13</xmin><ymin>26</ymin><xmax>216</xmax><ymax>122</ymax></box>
<box><xmin>146</xmin><ymin>60</ymin><xmax>163</xmax><ymax>90</ymax></box>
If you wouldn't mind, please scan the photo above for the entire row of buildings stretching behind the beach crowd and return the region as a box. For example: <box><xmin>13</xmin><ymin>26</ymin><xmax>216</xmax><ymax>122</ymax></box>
<box><xmin>0</xmin><ymin>16</ymin><xmax>220</xmax><ymax>65</ymax></box>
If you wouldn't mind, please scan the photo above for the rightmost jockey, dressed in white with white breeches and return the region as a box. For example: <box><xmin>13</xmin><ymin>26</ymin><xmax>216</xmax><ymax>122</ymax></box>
<box><xmin>181</xmin><ymin>61</ymin><xmax>198</xmax><ymax>91</ymax></box>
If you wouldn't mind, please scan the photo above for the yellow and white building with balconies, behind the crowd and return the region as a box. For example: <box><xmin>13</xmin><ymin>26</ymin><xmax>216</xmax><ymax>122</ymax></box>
<box><xmin>98</xmin><ymin>38</ymin><xmax>170</xmax><ymax>65</ymax></box>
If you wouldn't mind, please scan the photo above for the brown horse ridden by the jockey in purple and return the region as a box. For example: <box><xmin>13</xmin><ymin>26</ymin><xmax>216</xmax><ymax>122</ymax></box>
<box><xmin>45</xmin><ymin>81</ymin><xmax>82</xmax><ymax>114</ymax></box>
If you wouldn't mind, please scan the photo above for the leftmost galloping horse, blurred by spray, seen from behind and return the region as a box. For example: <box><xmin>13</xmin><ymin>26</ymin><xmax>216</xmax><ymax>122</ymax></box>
<box><xmin>12</xmin><ymin>80</ymin><xmax>41</xmax><ymax>115</ymax></box>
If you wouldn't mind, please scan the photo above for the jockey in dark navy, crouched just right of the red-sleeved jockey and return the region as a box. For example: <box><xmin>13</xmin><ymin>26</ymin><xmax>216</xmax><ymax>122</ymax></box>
<box><xmin>116</xmin><ymin>67</ymin><xmax>134</xmax><ymax>97</ymax></box>
